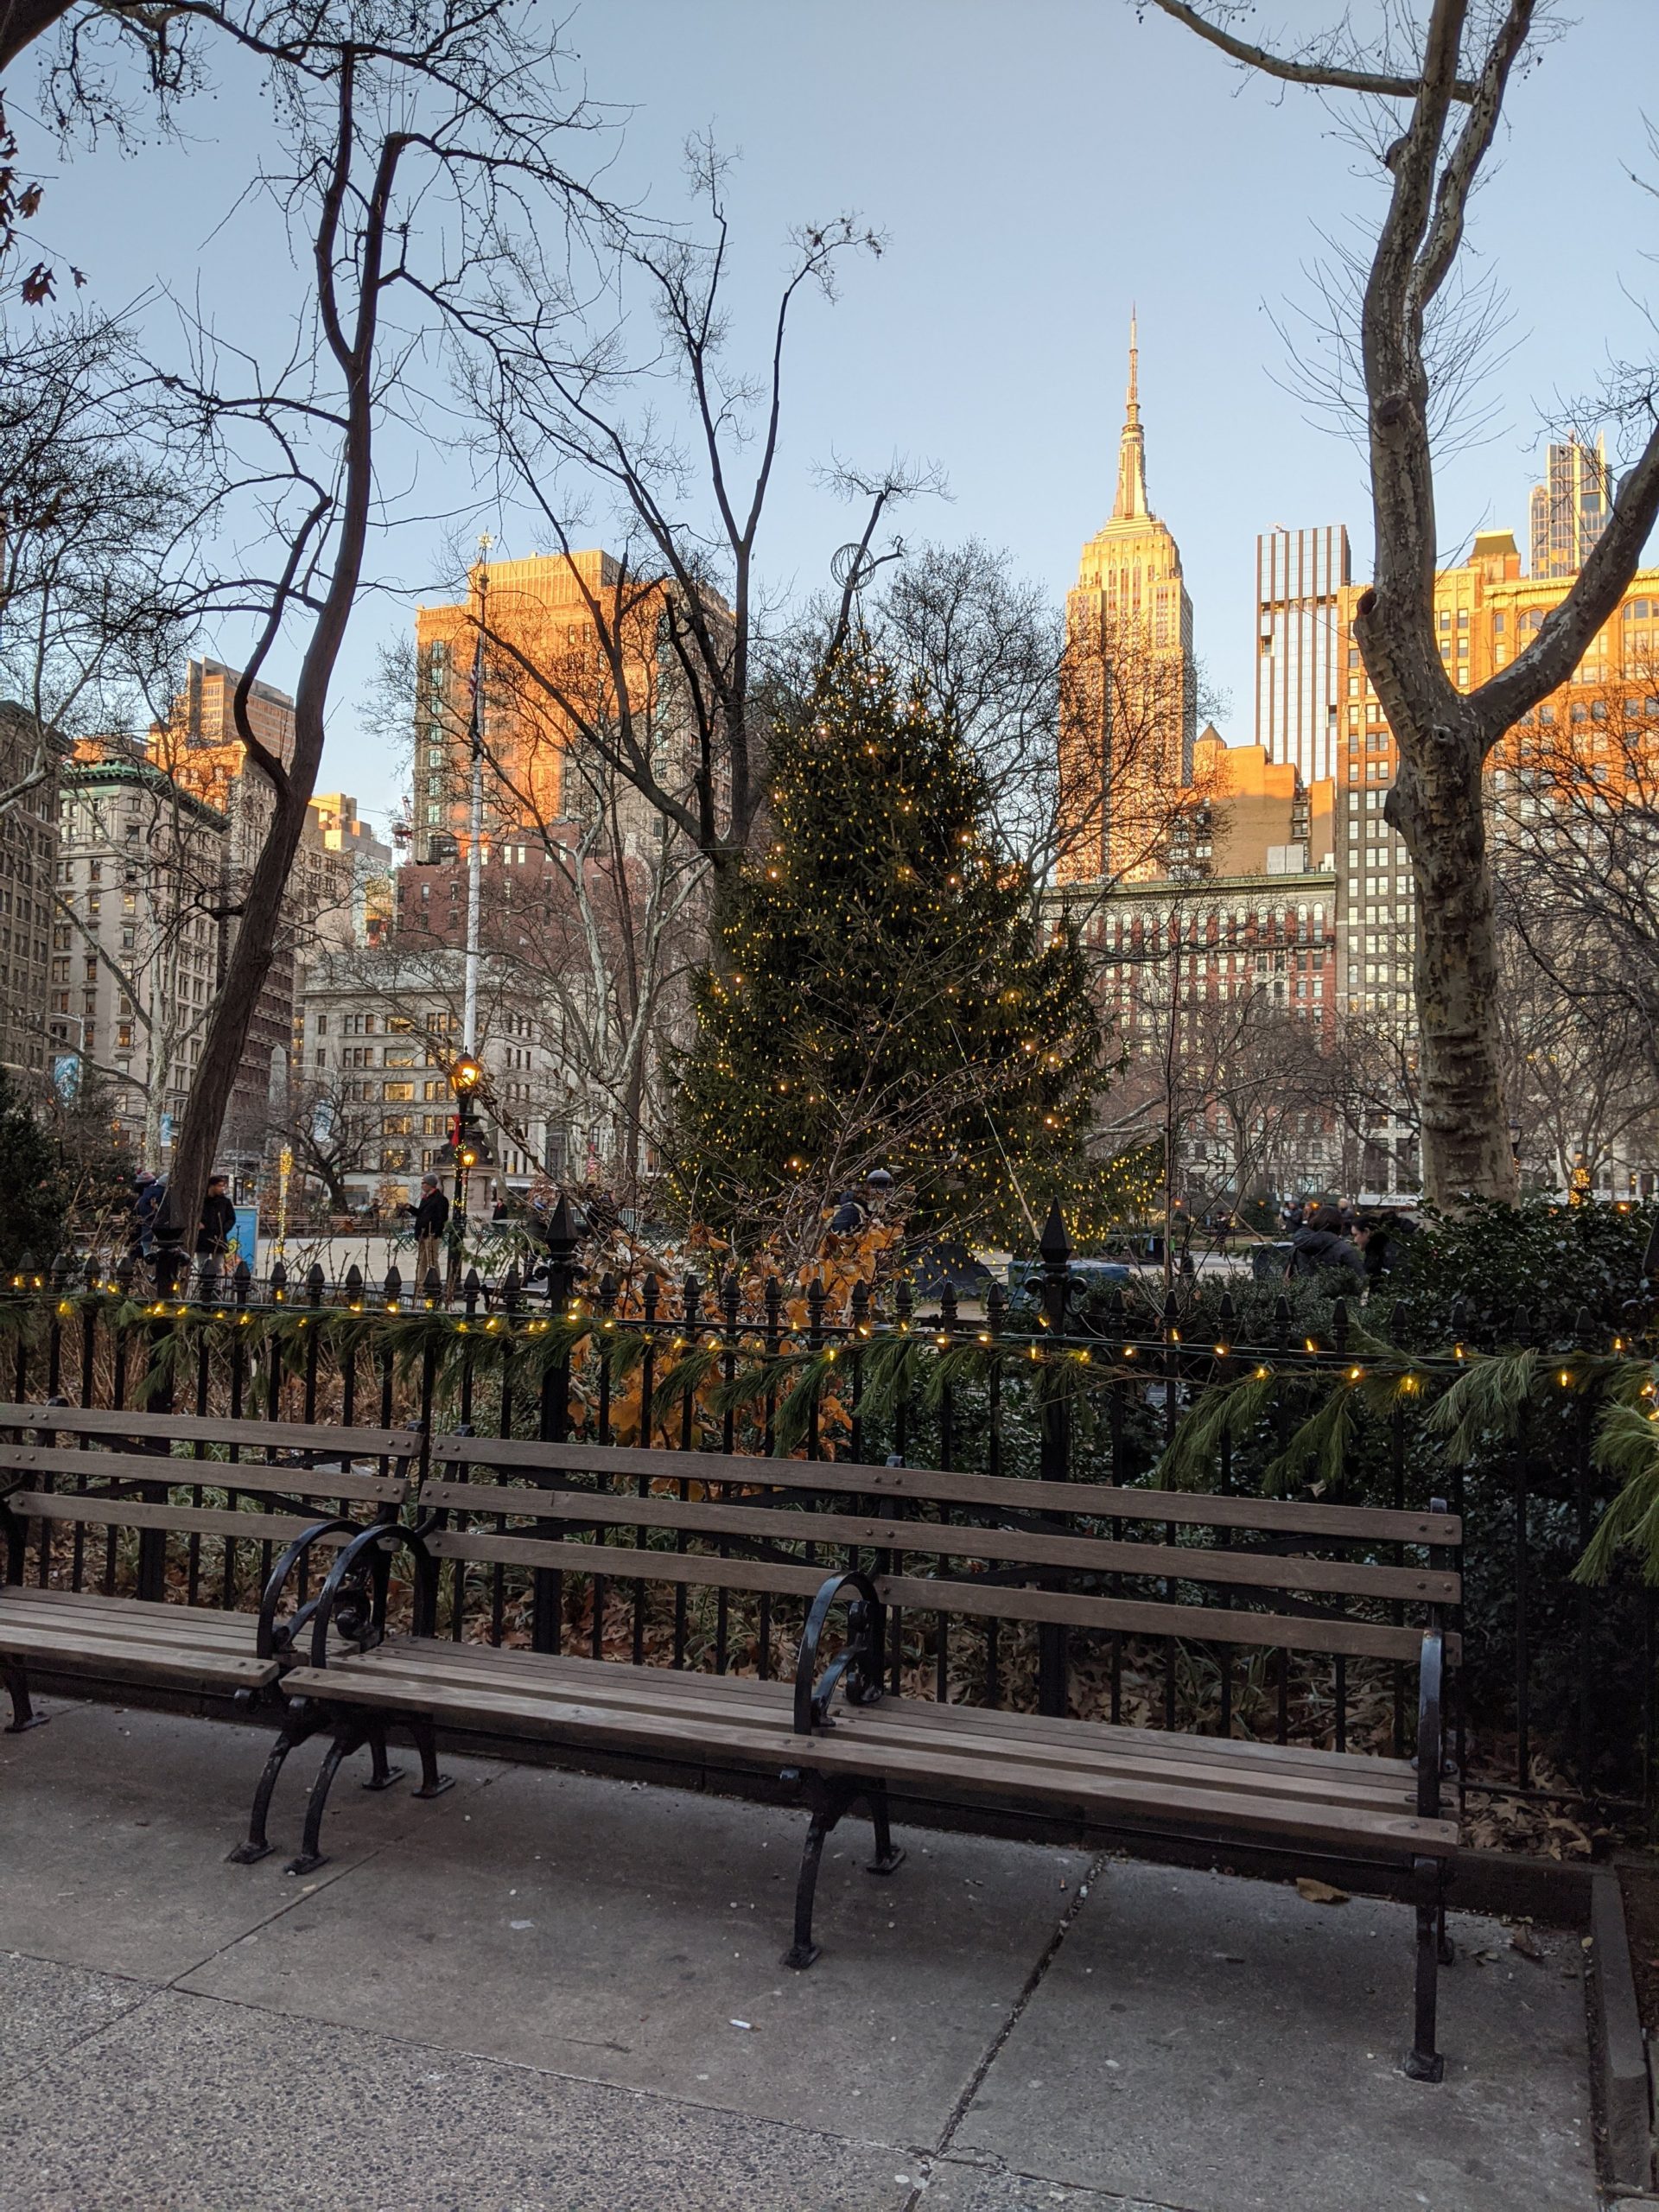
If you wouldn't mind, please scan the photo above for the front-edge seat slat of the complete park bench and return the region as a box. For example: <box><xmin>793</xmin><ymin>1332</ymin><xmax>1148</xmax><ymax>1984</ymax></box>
<box><xmin>285</xmin><ymin>1652</ymin><xmax>1458</xmax><ymax>1856</ymax></box>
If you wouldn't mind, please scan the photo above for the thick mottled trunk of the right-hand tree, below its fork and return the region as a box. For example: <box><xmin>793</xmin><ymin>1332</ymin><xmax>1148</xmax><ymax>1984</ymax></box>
<box><xmin>1385</xmin><ymin>726</ymin><xmax>1516</xmax><ymax>1208</ymax></box>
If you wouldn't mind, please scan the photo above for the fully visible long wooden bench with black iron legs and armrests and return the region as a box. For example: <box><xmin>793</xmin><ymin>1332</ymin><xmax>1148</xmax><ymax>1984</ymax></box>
<box><xmin>281</xmin><ymin>1435</ymin><xmax>1460</xmax><ymax>2079</ymax></box>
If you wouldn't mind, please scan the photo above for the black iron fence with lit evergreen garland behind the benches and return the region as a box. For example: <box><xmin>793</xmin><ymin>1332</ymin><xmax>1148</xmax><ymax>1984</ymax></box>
<box><xmin>0</xmin><ymin>1234</ymin><xmax>1659</xmax><ymax>1829</ymax></box>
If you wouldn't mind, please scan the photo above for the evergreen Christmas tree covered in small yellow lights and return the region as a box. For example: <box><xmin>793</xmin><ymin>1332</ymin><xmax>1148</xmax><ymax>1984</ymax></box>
<box><xmin>675</xmin><ymin>657</ymin><xmax>1102</xmax><ymax>1241</ymax></box>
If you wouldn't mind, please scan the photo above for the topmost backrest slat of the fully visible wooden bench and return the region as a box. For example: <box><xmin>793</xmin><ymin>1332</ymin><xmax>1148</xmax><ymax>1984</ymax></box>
<box><xmin>431</xmin><ymin>1435</ymin><xmax>1462</xmax><ymax>1546</ymax></box>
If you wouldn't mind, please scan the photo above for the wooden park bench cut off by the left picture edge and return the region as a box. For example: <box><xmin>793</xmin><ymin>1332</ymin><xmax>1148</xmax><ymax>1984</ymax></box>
<box><xmin>0</xmin><ymin>1405</ymin><xmax>423</xmax><ymax>1860</ymax></box>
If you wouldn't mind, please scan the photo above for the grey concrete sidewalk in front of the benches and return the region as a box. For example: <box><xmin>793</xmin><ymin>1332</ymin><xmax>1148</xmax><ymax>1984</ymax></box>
<box><xmin>0</xmin><ymin>1701</ymin><xmax>1595</xmax><ymax>2212</ymax></box>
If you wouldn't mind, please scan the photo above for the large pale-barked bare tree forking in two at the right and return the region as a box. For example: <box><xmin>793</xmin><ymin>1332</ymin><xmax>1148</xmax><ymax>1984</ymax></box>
<box><xmin>1148</xmin><ymin>0</ymin><xmax>1659</xmax><ymax>1204</ymax></box>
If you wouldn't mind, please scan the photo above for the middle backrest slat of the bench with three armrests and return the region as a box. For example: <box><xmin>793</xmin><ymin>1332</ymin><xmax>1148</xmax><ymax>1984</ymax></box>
<box><xmin>420</xmin><ymin>1476</ymin><xmax>1460</xmax><ymax>1606</ymax></box>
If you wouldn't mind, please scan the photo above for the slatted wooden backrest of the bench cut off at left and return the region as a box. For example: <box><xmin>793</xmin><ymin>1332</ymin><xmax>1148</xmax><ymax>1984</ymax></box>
<box><xmin>0</xmin><ymin>1405</ymin><xmax>423</xmax><ymax>1601</ymax></box>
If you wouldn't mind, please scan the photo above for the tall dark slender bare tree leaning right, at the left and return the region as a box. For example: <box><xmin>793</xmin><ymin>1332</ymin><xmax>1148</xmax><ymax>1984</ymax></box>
<box><xmin>155</xmin><ymin>0</ymin><xmax>610</xmax><ymax>1265</ymax></box>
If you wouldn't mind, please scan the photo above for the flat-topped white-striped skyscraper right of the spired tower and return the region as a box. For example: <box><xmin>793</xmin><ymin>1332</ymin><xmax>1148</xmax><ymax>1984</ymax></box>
<box><xmin>1256</xmin><ymin>522</ymin><xmax>1350</xmax><ymax>783</ymax></box>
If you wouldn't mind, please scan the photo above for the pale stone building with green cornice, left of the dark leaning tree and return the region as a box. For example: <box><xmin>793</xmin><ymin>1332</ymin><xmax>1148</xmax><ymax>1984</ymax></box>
<box><xmin>48</xmin><ymin>743</ymin><xmax>228</xmax><ymax>1168</ymax></box>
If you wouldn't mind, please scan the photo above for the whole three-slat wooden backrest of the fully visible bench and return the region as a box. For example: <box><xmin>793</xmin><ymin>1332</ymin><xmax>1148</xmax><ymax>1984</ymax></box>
<box><xmin>420</xmin><ymin>1435</ymin><xmax>1462</xmax><ymax>1659</ymax></box>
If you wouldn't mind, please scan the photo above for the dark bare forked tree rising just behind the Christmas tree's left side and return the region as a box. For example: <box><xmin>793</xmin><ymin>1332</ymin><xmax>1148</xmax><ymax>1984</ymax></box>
<box><xmin>462</xmin><ymin>143</ymin><xmax>925</xmax><ymax>896</ymax></box>
